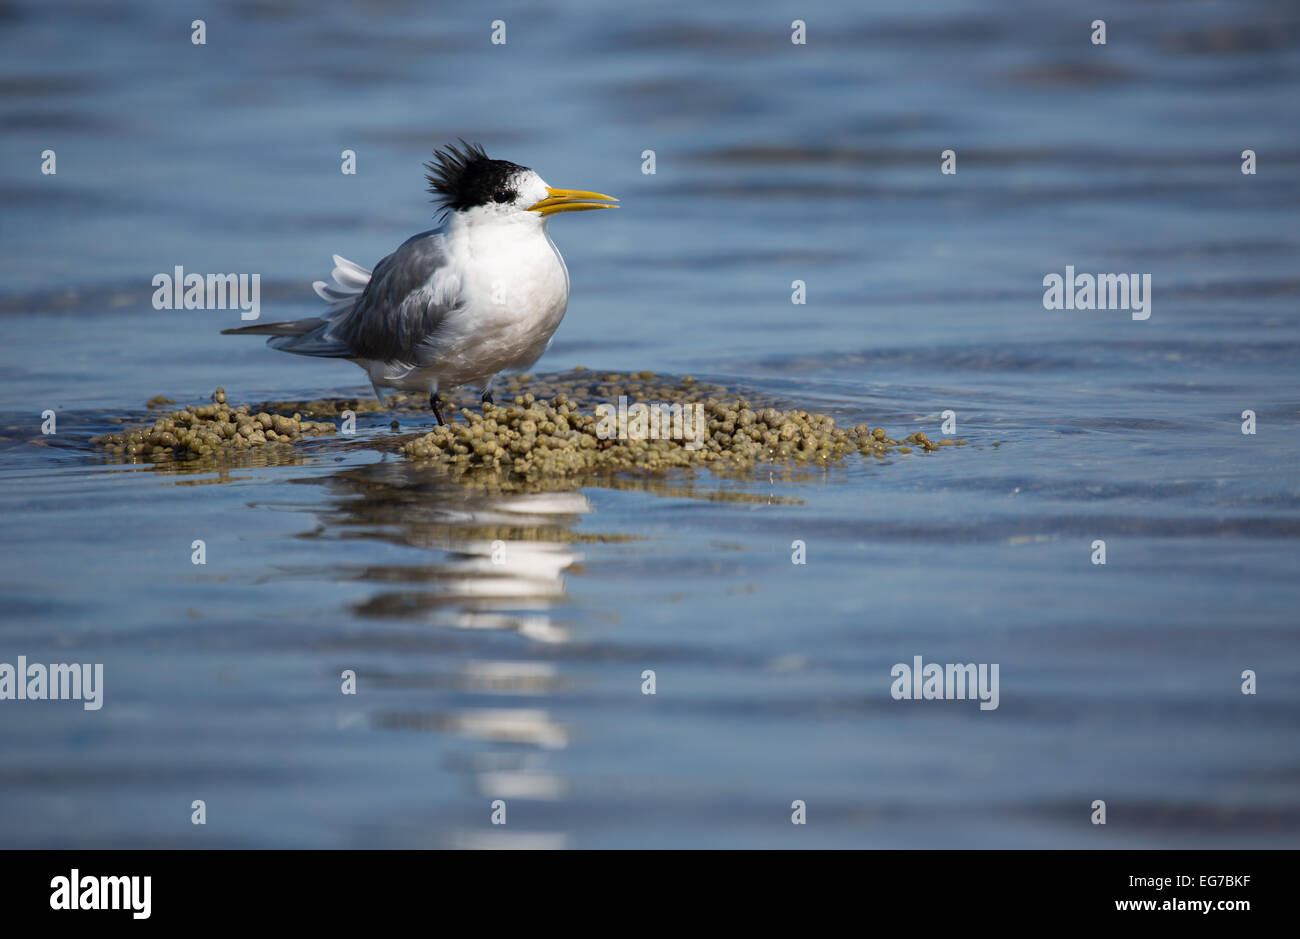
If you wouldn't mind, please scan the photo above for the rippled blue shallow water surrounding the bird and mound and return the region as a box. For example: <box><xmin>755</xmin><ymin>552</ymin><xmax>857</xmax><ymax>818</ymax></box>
<box><xmin>0</xmin><ymin>1</ymin><xmax>1300</xmax><ymax>847</ymax></box>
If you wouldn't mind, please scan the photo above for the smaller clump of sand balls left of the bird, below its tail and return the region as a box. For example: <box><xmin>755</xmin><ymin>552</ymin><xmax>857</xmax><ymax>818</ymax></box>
<box><xmin>91</xmin><ymin>388</ymin><xmax>337</xmax><ymax>463</ymax></box>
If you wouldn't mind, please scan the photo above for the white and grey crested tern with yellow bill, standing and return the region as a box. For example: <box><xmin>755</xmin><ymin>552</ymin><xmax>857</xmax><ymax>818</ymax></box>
<box><xmin>221</xmin><ymin>138</ymin><xmax>619</xmax><ymax>425</ymax></box>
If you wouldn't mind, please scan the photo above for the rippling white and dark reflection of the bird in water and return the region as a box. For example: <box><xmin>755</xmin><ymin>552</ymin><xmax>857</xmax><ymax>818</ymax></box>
<box><xmin>312</xmin><ymin>462</ymin><xmax>592</xmax><ymax>848</ymax></box>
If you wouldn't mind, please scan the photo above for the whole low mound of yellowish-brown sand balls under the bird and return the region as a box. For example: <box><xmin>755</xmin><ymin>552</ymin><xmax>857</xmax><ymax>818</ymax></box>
<box><xmin>92</xmin><ymin>368</ymin><xmax>965</xmax><ymax>486</ymax></box>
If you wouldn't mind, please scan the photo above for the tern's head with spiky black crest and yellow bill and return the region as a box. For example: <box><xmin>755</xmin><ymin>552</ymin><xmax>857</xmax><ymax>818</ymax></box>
<box><xmin>425</xmin><ymin>140</ymin><xmax>618</xmax><ymax>220</ymax></box>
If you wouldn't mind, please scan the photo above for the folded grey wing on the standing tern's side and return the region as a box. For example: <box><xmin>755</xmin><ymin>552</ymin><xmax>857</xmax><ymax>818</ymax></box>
<box><xmin>328</xmin><ymin>230</ymin><xmax>462</xmax><ymax>364</ymax></box>
